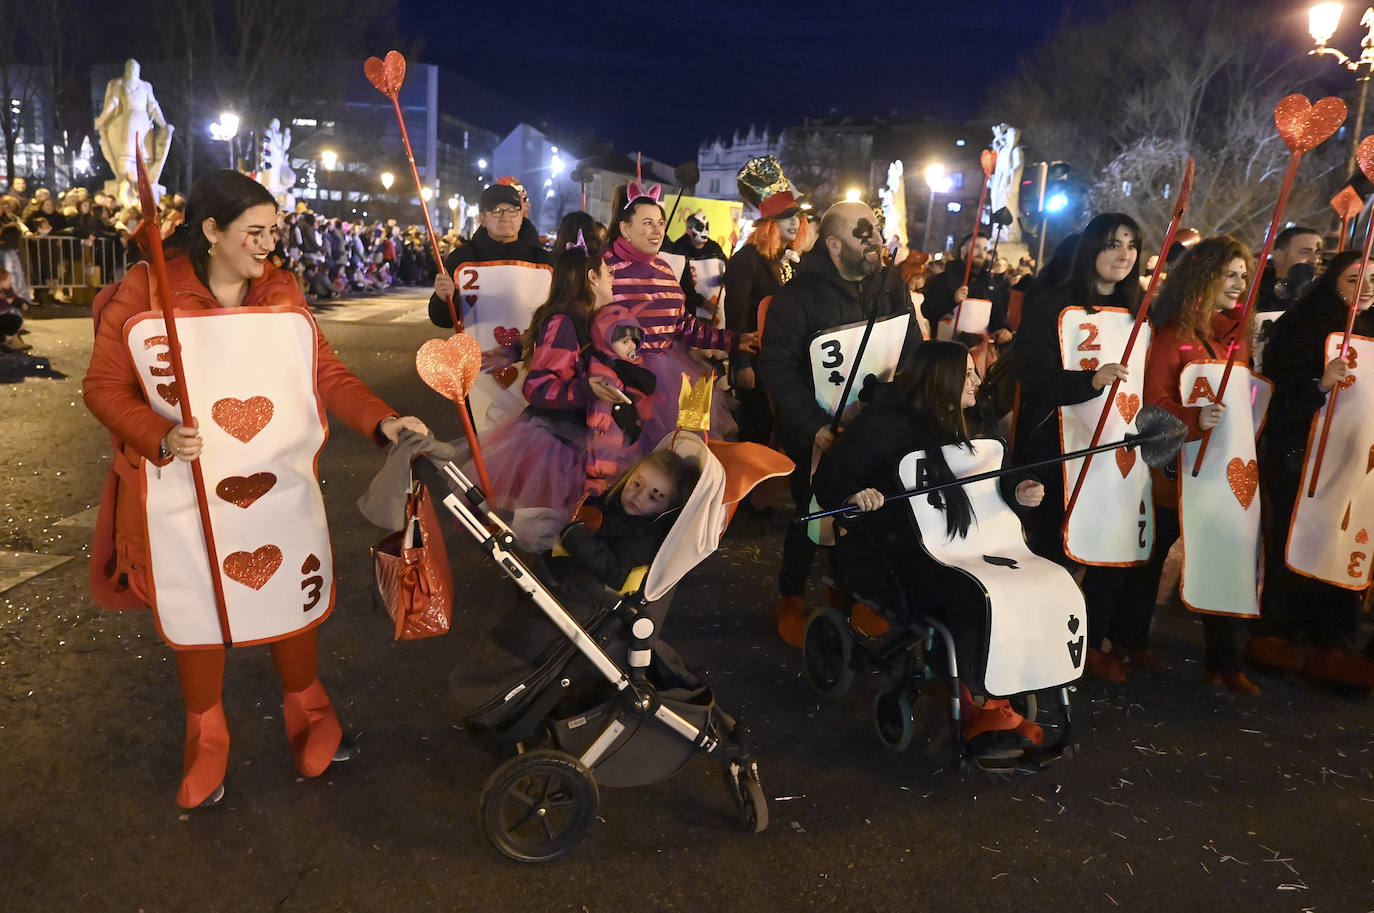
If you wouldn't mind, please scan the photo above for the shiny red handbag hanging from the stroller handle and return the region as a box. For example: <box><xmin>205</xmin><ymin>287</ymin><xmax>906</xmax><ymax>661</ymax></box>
<box><xmin>372</xmin><ymin>481</ymin><xmax>453</xmax><ymax>641</ymax></box>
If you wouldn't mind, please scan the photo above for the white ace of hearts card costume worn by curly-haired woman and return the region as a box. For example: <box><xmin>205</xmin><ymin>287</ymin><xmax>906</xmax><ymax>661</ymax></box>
<box><xmin>1179</xmin><ymin>359</ymin><xmax>1274</xmax><ymax>619</ymax></box>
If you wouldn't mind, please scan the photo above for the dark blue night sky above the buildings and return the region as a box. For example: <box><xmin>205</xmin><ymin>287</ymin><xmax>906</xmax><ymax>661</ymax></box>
<box><xmin>398</xmin><ymin>0</ymin><xmax>1065</xmax><ymax>162</ymax></box>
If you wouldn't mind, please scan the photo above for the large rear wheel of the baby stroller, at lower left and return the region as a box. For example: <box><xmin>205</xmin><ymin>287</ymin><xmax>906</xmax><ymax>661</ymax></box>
<box><xmin>481</xmin><ymin>749</ymin><xmax>598</xmax><ymax>862</ymax></box>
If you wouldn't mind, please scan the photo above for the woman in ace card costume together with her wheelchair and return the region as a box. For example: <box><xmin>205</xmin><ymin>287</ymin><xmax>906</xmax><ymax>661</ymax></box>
<box><xmin>804</xmin><ymin>342</ymin><xmax>1083</xmax><ymax>767</ymax></box>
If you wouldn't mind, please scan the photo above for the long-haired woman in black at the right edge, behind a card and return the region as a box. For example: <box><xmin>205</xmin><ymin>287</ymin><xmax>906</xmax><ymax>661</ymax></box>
<box><xmin>1249</xmin><ymin>250</ymin><xmax>1374</xmax><ymax>688</ymax></box>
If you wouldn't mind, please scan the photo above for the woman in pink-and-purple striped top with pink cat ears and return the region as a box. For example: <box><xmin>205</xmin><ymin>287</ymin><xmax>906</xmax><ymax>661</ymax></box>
<box><xmin>602</xmin><ymin>183</ymin><xmax>758</xmax><ymax>442</ymax></box>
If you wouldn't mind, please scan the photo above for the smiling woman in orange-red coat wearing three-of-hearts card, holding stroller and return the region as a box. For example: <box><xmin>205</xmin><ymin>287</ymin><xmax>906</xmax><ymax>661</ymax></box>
<box><xmin>82</xmin><ymin>171</ymin><xmax>427</xmax><ymax>809</ymax></box>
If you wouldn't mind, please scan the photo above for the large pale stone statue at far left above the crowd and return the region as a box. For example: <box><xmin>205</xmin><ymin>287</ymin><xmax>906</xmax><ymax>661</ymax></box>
<box><xmin>95</xmin><ymin>58</ymin><xmax>173</xmax><ymax>206</ymax></box>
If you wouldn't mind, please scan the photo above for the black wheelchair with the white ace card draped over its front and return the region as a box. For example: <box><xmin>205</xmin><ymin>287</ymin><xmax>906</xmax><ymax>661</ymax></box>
<box><xmin>802</xmin><ymin>440</ymin><xmax>1087</xmax><ymax>771</ymax></box>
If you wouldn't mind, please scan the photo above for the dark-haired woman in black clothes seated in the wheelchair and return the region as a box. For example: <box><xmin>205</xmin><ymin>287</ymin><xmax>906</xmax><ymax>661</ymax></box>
<box><xmin>812</xmin><ymin>340</ymin><xmax>1044</xmax><ymax>756</ymax></box>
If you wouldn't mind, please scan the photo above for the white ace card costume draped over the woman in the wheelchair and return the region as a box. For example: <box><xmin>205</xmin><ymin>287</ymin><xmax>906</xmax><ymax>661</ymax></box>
<box><xmin>897</xmin><ymin>439</ymin><xmax>1088</xmax><ymax>697</ymax></box>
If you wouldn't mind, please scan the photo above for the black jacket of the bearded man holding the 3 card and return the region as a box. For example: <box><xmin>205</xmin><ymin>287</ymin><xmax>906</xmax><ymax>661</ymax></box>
<box><xmin>763</xmin><ymin>245</ymin><xmax>922</xmax><ymax>458</ymax></box>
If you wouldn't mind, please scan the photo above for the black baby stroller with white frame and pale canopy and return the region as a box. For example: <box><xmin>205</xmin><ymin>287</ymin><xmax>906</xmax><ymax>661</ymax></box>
<box><xmin>423</xmin><ymin>432</ymin><xmax>790</xmax><ymax>862</ymax></box>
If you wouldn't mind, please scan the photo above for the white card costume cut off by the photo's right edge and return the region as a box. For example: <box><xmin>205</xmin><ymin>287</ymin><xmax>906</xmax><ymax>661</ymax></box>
<box><xmin>1285</xmin><ymin>333</ymin><xmax>1374</xmax><ymax>590</ymax></box>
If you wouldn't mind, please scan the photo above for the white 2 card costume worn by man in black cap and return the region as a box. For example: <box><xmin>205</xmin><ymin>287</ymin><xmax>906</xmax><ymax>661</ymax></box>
<box><xmin>453</xmin><ymin>260</ymin><xmax>554</xmax><ymax>435</ymax></box>
